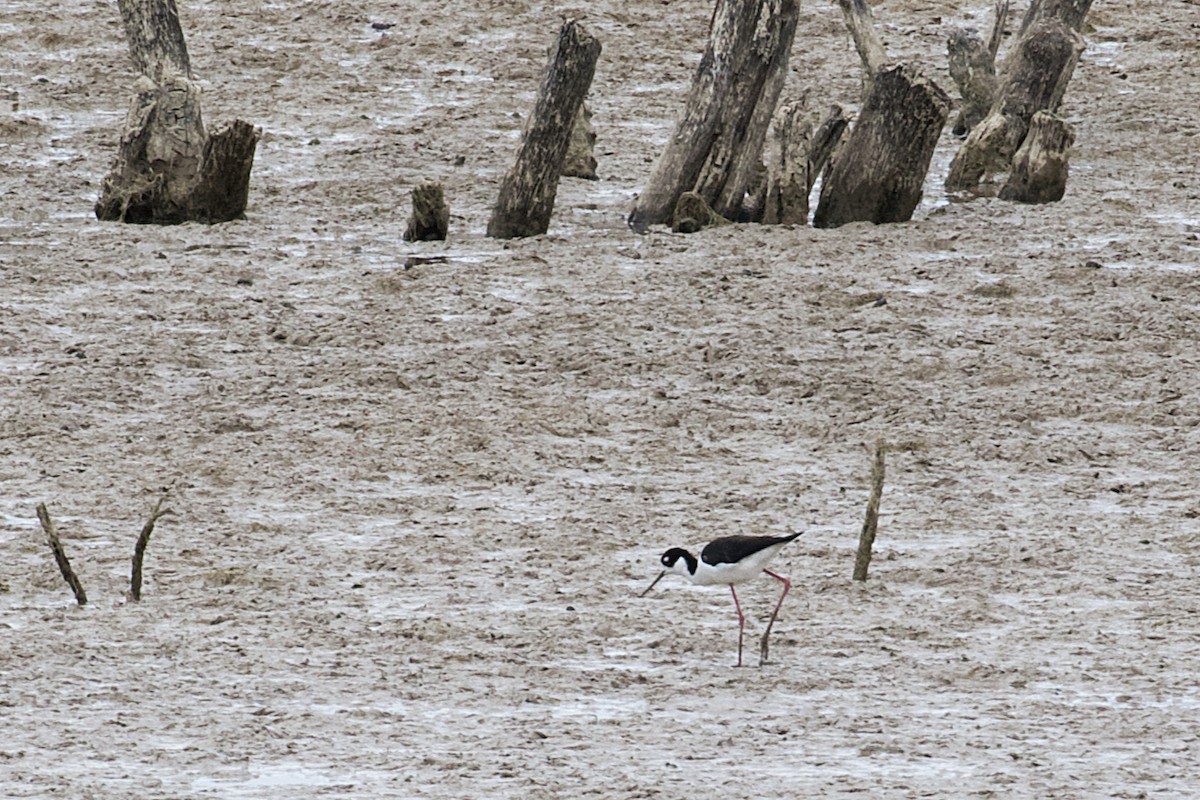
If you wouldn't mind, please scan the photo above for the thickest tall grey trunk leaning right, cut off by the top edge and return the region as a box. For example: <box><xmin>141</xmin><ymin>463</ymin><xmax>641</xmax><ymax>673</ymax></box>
<box><xmin>629</xmin><ymin>0</ymin><xmax>799</xmax><ymax>231</ymax></box>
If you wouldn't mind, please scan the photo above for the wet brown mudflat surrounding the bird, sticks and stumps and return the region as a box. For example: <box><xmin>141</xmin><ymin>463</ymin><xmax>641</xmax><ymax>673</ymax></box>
<box><xmin>0</xmin><ymin>0</ymin><xmax>1200</xmax><ymax>800</ymax></box>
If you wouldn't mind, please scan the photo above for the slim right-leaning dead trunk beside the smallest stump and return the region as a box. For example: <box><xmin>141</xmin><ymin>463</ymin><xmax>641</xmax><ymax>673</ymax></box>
<box><xmin>487</xmin><ymin>19</ymin><xmax>600</xmax><ymax>239</ymax></box>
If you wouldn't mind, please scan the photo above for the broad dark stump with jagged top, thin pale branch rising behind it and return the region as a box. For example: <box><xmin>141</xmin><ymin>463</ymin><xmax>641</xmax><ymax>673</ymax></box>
<box><xmin>812</xmin><ymin>65</ymin><xmax>950</xmax><ymax>228</ymax></box>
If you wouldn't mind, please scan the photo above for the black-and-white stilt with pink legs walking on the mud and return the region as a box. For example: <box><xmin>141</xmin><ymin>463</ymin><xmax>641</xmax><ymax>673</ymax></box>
<box><xmin>640</xmin><ymin>531</ymin><xmax>804</xmax><ymax>667</ymax></box>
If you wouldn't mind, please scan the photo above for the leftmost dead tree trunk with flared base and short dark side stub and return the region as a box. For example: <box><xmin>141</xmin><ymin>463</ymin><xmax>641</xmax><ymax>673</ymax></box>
<box><xmin>96</xmin><ymin>0</ymin><xmax>262</xmax><ymax>224</ymax></box>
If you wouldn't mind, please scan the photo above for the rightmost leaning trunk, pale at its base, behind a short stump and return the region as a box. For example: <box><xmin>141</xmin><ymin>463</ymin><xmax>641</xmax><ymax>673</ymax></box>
<box><xmin>946</xmin><ymin>19</ymin><xmax>1084</xmax><ymax>192</ymax></box>
